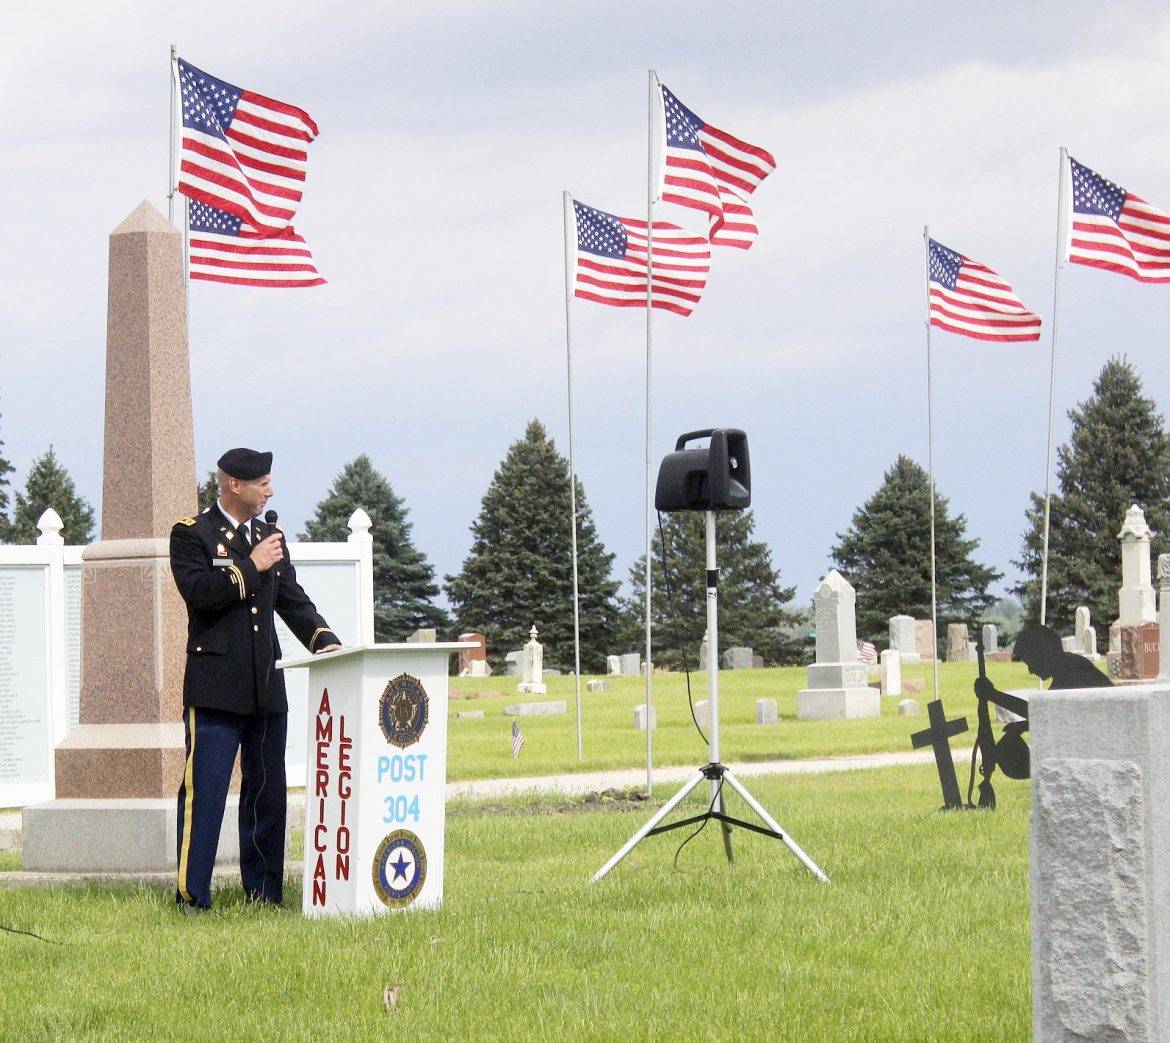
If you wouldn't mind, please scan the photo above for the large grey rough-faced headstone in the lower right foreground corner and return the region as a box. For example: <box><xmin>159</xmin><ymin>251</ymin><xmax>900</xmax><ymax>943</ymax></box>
<box><xmin>1028</xmin><ymin>685</ymin><xmax>1170</xmax><ymax>1043</ymax></box>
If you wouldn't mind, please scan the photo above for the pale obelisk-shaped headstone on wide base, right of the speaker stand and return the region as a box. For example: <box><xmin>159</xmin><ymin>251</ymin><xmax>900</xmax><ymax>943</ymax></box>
<box><xmin>797</xmin><ymin>569</ymin><xmax>881</xmax><ymax>720</ymax></box>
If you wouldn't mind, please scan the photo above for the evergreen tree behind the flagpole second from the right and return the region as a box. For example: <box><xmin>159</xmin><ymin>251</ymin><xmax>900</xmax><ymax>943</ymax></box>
<box><xmin>830</xmin><ymin>455</ymin><xmax>1003</xmax><ymax>641</ymax></box>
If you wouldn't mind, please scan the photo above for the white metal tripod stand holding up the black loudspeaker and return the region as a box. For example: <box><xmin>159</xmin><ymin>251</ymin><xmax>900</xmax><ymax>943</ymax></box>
<box><xmin>593</xmin><ymin>501</ymin><xmax>828</xmax><ymax>884</ymax></box>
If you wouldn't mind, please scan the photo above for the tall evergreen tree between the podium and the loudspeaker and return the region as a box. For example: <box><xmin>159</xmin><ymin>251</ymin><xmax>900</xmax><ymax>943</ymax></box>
<box><xmin>446</xmin><ymin>420</ymin><xmax>618</xmax><ymax>672</ymax></box>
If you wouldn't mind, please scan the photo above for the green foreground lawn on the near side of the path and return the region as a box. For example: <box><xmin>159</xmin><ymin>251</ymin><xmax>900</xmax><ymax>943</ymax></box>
<box><xmin>0</xmin><ymin>758</ymin><xmax>1031</xmax><ymax>1041</ymax></box>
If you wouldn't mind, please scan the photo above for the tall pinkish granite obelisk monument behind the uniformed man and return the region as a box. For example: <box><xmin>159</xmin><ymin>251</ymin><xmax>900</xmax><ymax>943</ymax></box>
<box><xmin>23</xmin><ymin>201</ymin><xmax>230</xmax><ymax>872</ymax></box>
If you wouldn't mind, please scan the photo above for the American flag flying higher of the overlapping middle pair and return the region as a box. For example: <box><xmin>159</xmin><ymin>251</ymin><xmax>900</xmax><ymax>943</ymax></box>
<box><xmin>658</xmin><ymin>84</ymin><xmax>776</xmax><ymax>249</ymax></box>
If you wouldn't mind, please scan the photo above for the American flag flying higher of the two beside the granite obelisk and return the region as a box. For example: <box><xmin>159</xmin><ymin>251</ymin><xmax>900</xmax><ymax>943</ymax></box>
<box><xmin>177</xmin><ymin>59</ymin><xmax>317</xmax><ymax>232</ymax></box>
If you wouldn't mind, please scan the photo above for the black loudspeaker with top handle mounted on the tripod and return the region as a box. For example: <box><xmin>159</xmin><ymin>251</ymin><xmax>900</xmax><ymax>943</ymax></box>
<box><xmin>654</xmin><ymin>427</ymin><xmax>751</xmax><ymax>512</ymax></box>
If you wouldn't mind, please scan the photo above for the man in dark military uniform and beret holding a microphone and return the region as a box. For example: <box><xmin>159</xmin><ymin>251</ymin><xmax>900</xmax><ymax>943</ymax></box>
<box><xmin>171</xmin><ymin>448</ymin><xmax>339</xmax><ymax>912</ymax></box>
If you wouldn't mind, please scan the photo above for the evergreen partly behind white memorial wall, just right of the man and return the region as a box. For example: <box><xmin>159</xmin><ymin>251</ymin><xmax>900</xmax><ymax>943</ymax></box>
<box><xmin>301</xmin><ymin>453</ymin><xmax>450</xmax><ymax>641</ymax></box>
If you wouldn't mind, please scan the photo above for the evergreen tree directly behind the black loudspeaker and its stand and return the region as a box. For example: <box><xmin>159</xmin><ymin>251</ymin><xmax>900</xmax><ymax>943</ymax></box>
<box><xmin>622</xmin><ymin>510</ymin><xmax>805</xmax><ymax>670</ymax></box>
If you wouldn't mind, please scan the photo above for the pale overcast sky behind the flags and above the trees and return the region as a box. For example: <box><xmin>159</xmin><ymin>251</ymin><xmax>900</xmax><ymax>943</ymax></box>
<box><xmin>0</xmin><ymin>0</ymin><xmax>1170</xmax><ymax>603</ymax></box>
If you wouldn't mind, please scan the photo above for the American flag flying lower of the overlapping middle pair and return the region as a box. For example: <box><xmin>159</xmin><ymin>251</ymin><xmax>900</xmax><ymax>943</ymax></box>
<box><xmin>573</xmin><ymin>199</ymin><xmax>711</xmax><ymax>315</ymax></box>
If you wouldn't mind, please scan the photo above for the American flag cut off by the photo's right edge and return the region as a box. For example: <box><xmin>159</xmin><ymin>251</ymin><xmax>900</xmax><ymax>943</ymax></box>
<box><xmin>1068</xmin><ymin>156</ymin><xmax>1170</xmax><ymax>282</ymax></box>
